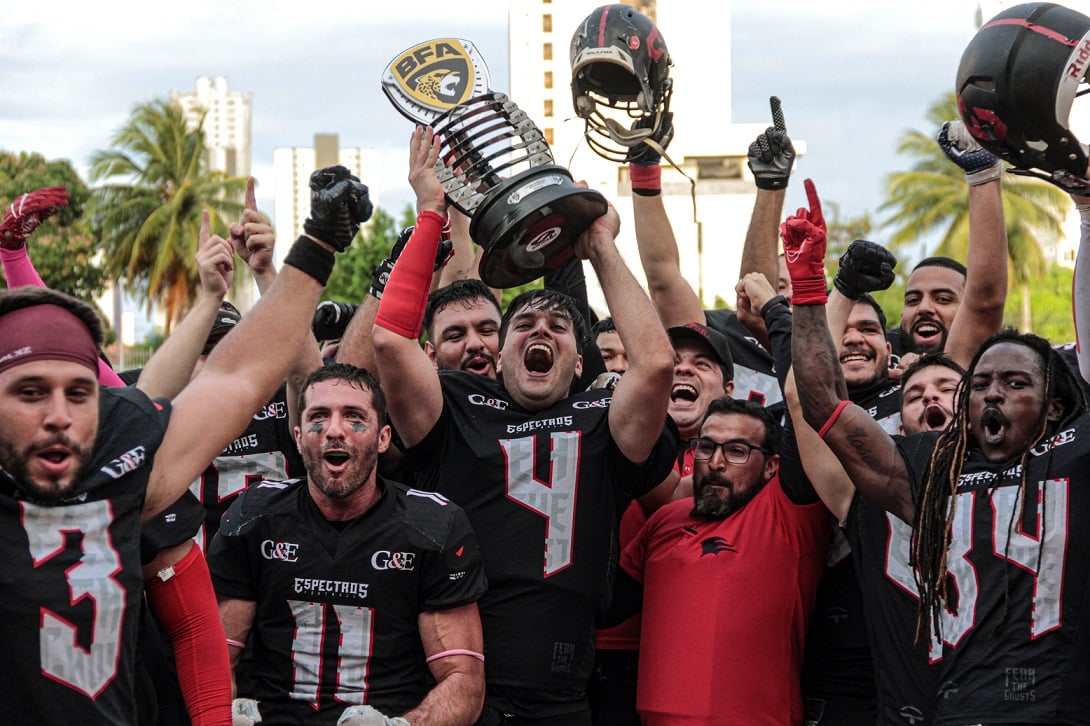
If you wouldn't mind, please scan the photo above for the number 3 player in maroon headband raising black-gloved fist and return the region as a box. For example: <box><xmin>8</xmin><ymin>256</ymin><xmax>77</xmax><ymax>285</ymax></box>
<box><xmin>0</xmin><ymin>170</ymin><xmax>370</xmax><ymax>724</ymax></box>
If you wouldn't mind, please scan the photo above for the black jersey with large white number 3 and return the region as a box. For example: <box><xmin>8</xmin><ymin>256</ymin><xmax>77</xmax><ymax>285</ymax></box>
<box><xmin>0</xmin><ymin>381</ymin><xmax>169</xmax><ymax>725</ymax></box>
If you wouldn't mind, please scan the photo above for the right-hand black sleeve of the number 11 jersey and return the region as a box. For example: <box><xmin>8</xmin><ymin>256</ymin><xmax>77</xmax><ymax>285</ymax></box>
<box><xmin>421</xmin><ymin>495</ymin><xmax>488</xmax><ymax>612</ymax></box>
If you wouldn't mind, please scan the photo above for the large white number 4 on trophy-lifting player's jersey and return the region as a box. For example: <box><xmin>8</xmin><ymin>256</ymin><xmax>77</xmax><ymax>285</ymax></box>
<box><xmin>499</xmin><ymin>431</ymin><xmax>581</xmax><ymax>577</ymax></box>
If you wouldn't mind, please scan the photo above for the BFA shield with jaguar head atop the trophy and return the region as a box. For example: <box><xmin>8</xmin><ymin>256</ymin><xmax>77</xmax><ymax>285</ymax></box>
<box><xmin>383</xmin><ymin>38</ymin><xmax>488</xmax><ymax>124</ymax></box>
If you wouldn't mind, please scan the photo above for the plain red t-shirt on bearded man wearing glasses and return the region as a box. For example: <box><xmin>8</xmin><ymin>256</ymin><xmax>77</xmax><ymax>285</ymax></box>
<box><xmin>621</xmin><ymin>476</ymin><xmax>829</xmax><ymax>726</ymax></box>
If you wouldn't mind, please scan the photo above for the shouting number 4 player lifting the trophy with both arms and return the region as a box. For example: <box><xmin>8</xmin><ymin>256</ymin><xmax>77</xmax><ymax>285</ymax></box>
<box><xmin>374</xmin><ymin>128</ymin><xmax>677</xmax><ymax>725</ymax></box>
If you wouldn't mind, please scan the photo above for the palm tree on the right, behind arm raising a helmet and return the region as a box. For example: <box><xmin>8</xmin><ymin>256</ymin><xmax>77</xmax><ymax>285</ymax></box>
<box><xmin>880</xmin><ymin>93</ymin><xmax>1071</xmax><ymax>330</ymax></box>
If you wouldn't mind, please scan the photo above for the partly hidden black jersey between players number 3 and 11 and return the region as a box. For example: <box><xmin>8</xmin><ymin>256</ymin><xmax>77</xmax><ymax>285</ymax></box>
<box><xmin>190</xmin><ymin>385</ymin><xmax>304</xmax><ymax>548</ymax></box>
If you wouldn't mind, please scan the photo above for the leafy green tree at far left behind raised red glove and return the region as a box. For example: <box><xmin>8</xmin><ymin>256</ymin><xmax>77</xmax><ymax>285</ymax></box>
<box><xmin>0</xmin><ymin>152</ymin><xmax>105</xmax><ymax>303</ymax></box>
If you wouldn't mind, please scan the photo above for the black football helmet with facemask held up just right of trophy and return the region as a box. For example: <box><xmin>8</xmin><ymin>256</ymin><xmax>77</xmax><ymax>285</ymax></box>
<box><xmin>571</xmin><ymin>4</ymin><xmax>673</xmax><ymax>161</ymax></box>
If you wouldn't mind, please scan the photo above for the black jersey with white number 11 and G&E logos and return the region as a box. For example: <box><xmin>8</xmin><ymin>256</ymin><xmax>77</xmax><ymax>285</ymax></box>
<box><xmin>208</xmin><ymin>479</ymin><xmax>487</xmax><ymax>725</ymax></box>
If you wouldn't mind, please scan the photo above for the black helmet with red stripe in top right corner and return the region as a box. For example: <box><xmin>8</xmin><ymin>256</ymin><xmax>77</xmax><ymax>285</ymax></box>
<box><xmin>956</xmin><ymin>2</ymin><xmax>1090</xmax><ymax>194</ymax></box>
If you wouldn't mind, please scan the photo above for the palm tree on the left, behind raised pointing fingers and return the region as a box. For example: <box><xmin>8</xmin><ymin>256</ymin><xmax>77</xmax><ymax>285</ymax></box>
<box><xmin>90</xmin><ymin>99</ymin><xmax>245</xmax><ymax>334</ymax></box>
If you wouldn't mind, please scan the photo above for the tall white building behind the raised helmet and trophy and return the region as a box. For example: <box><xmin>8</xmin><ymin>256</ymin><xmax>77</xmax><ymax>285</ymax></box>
<box><xmin>505</xmin><ymin>0</ymin><xmax>806</xmax><ymax>313</ymax></box>
